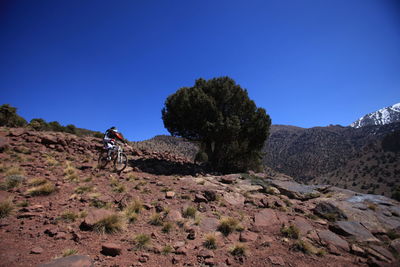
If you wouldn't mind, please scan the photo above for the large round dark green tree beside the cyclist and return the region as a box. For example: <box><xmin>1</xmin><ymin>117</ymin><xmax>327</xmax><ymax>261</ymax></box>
<box><xmin>162</xmin><ymin>77</ymin><xmax>271</xmax><ymax>172</ymax></box>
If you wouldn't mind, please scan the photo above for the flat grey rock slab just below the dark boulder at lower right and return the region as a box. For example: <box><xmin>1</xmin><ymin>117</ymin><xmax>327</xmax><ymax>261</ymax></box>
<box><xmin>330</xmin><ymin>221</ymin><xmax>380</xmax><ymax>242</ymax></box>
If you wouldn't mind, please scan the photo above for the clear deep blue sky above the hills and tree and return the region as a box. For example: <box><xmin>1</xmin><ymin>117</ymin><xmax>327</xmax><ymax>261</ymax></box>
<box><xmin>0</xmin><ymin>0</ymin><xmax>400</xmax><ymax>141</ymax></box>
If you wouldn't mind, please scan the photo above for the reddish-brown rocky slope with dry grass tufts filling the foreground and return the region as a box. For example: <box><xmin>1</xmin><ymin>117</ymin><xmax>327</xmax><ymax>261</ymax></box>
<box><xmin>0</xmin><ymin>128</ymin><xmax>400</xmax><ymax>266</ymax></box>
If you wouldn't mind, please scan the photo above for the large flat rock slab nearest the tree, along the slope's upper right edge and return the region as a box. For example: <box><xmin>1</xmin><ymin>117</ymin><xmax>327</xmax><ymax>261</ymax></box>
<box><xmin>271</xmin><ymin>180</ymin><xmax>321</xmax><ymax>200</ymax></box>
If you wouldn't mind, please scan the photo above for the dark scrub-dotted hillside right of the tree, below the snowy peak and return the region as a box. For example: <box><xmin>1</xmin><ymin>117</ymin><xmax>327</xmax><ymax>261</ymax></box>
<box><xmin>264</xmin><ymin>123</ymin><xmax>400</xmax><ymax>195</ymax></box>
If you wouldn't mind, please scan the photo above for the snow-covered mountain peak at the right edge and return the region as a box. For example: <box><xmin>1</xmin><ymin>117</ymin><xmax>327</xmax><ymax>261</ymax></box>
<box><xmin>350</xmin><ymin>103</ymin><xmax>400</xmax><ymax>128</ymax></box>
